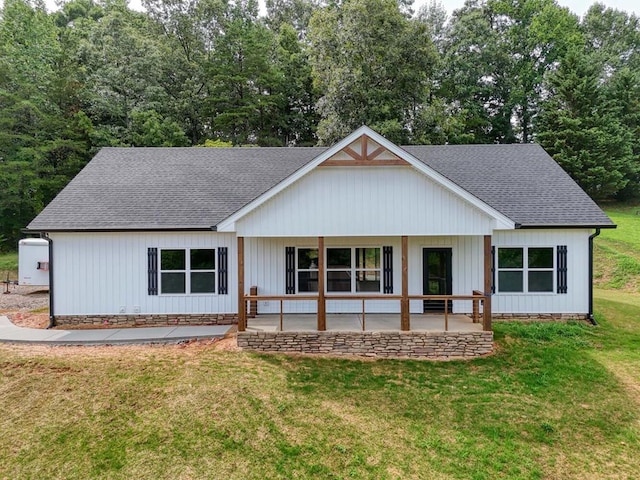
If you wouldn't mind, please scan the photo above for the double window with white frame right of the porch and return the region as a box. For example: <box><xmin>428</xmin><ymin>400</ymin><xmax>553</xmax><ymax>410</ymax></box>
<box><xmin>498</xmin><ymin>247</ymin><xmax>554</xmax><ymax>293</ymax></box>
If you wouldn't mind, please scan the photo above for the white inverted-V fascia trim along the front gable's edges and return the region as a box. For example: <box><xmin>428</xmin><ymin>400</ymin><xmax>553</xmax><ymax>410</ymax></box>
<box><xmin>217</xmin><ymin>125</ymin><xmax>516</xmax><ymax>232</ymax></box>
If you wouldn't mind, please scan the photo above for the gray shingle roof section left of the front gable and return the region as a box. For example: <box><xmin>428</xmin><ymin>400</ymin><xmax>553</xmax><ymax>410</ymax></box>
<box><xmin>28</xmin><ymin>147</ymin><xmax>325</xmax><ymax>230</ymax></box>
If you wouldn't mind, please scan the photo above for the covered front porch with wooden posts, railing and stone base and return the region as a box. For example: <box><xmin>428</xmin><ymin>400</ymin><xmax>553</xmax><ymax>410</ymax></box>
<box><xmin>237</xmin><ymin>235</ymin><xmax>493</xmax><ymax>358</ymax></box>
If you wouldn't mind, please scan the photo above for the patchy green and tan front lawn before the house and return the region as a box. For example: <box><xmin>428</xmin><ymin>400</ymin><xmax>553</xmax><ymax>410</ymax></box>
<box><xmin>0</xmin><ymin>291</ymin><xmax>640</xmax><ymax>479</ymax></box>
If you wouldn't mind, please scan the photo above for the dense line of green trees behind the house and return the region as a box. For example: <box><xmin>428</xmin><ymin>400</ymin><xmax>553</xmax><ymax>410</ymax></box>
<box><xmin>0</xmin><ymin>0</ymin><xmax>640</xmax><ymax>248</ymax></box>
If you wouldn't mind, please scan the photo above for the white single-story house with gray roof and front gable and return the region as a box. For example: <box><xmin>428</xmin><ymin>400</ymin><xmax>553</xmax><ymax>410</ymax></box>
<box><xmin>27</xmin><ymin>126</ymin><xmax>614</xmax><ymax>356</ymax></box>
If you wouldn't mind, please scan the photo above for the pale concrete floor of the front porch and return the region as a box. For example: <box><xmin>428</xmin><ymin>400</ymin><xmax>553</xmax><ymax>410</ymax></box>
<box><xmin>247</xmin><ymin>313</ymin><xmax>482</xmax><ymax>332</ymax></box>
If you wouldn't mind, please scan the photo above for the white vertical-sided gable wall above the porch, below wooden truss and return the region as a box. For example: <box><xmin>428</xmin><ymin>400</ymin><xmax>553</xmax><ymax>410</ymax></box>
<box><xmin>236</xmin><ymin>166</ymin><xmax>495</xmax><ymax>237</ymax></box>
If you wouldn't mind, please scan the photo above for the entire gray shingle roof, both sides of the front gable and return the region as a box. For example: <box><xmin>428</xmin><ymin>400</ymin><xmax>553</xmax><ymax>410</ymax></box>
<box><xmin>28</xmin><ymin>144</ymin><xmax>612</xmax><ymax>231</ymax></box>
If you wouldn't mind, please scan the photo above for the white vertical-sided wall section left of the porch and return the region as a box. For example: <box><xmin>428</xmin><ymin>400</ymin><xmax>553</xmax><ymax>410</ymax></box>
<box><xmin>50</xmin><ymin>232</ymin><xmax>238</xmax><ymax>315</ymax></box>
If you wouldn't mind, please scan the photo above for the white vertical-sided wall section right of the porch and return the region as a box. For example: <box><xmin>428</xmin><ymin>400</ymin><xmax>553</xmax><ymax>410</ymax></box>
<box><xmin>491</xmin><ymin>229</ymin><xmax>592</xmax><ymax>314</ymax></box>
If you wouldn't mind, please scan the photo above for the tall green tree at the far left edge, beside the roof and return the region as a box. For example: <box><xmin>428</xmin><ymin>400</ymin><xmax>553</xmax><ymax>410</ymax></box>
<box><xmin>0</xmin><ymin>0</ymin><xmax>88</xmax><ymax>246</ymax></box>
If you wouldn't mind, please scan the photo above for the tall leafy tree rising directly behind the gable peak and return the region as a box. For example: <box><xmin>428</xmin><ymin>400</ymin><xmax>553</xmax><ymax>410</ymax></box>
<box><xmin>309</xmin><ymin>0</ymin><xmax>436</xmax><ymax>144</ymax></box>
